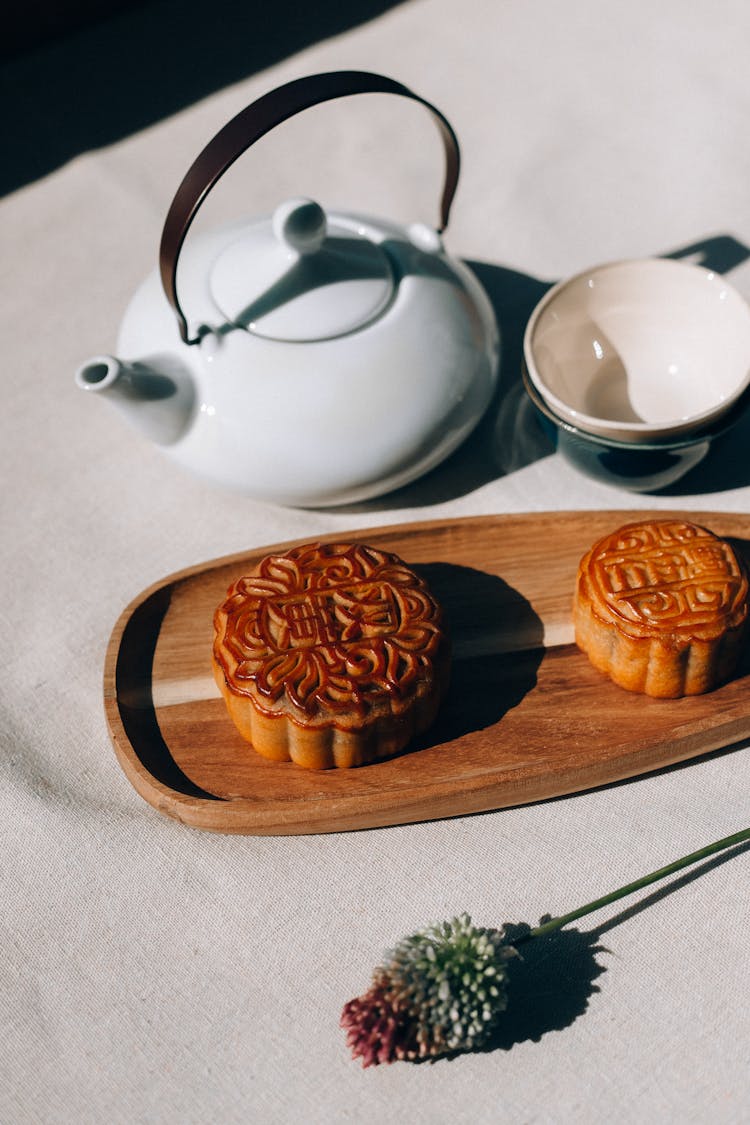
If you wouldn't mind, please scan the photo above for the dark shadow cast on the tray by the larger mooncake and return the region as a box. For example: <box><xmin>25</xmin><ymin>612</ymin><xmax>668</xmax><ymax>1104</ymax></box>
<box><xmin>412</xmin><ymin>563</ymin><xmax>543</xmax><ymax>749</ymax></box>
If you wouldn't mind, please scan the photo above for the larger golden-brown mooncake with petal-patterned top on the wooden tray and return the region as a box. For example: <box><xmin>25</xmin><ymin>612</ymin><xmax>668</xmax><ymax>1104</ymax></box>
<box><xmin>214</xmin><ymin>543</ymin><xmax>450</xmax><ymax>770</ymax></box>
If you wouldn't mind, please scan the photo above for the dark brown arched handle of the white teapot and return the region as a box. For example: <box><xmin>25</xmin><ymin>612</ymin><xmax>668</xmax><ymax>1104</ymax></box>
<box><xmin>159</xmin><ymin>71</ymin><xmax>460</xmax><ymax>344</ymax></box>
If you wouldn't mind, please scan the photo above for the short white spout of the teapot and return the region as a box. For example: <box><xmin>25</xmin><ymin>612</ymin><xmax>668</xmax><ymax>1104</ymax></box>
<box><xmin>75</xmin><ymin>356</ymin><xmax>195</xmax><ymax>446</ymax></box>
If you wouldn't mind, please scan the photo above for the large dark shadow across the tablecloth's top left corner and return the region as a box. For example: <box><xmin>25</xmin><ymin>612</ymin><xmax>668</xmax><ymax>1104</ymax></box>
<box><xmin>0</xmin><ymin>0</ymin><xmax>401</xmax><ymax>195</ymax></box>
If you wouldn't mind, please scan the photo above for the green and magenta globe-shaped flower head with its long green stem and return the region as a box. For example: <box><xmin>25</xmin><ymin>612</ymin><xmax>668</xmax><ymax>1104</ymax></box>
<box><xmin>341</xmin><ymin>828</ymin><xmax>750</xmax><ymax>1067</ymax></box>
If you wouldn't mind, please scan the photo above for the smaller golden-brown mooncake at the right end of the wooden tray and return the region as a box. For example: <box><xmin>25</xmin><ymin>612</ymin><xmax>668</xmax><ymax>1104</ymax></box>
<box><xmin>573</xmin><ymin>520</ymin><xmax>748</xmax><ymax>699</ymax></box>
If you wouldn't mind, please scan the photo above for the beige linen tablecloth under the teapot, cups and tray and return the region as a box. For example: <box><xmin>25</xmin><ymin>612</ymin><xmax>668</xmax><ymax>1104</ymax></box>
<box><xmin>0</xmin><ymin>0</ymin><xmax>750</xmax><ymax>1125</ymax></box>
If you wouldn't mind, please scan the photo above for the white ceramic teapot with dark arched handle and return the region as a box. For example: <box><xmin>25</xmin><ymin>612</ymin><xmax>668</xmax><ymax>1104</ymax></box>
<box><xmin>75</xmin><ymin>71</ymin><xmax>499</xmax><ymax>506</ymax></box>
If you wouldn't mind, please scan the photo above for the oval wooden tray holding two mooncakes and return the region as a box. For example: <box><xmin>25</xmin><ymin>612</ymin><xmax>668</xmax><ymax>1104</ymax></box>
<box><xmin>105</xmin><ymin>511</ymin><xmax>750</xmax><ymax>835</ymax></box>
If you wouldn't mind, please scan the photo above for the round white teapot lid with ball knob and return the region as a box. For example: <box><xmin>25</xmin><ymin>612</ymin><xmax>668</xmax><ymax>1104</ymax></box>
<box><xmin>209</xmin><ymin>199</ymin><xmax>396</xmax><ymax>343</ymax></box>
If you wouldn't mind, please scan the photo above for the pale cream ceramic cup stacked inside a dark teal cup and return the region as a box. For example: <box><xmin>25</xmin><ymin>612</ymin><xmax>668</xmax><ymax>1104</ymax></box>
<box><xmin>524</xmin><ymin>259</ymin><xmax>750</xmax><ymax>444</ymax></box>
